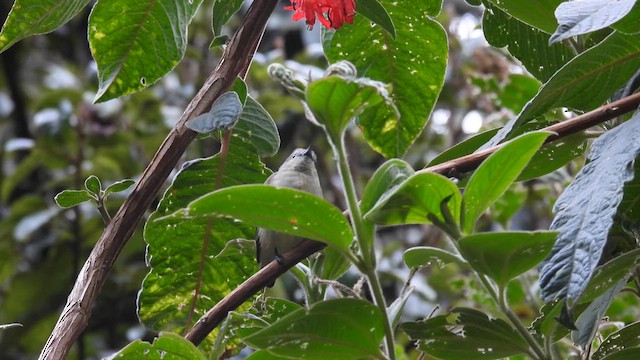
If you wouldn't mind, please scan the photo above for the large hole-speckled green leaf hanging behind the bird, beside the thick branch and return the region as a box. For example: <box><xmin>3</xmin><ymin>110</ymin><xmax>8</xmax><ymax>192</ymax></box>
<box><xmin>138</xmin><ymin>138</ymin><xmax>268</xmax><ymax>346</ymax></box>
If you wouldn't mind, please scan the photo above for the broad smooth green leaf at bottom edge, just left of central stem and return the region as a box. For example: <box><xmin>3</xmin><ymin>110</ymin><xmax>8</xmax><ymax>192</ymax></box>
<box><xmin>237</xmin><ymin>299</ymin><xmax>384</xmax><ymax>360</ymax></box>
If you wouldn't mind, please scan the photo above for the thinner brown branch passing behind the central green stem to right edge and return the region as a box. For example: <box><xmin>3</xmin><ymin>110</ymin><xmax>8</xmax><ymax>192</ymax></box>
<box><xmin>186</xmin><ymin>93</ymin><xmax>640</xmax><ymax>345</ymax></box>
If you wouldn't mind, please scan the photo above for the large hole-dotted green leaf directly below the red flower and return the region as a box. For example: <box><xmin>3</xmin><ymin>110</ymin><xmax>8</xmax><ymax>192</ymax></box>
<box><xmin>324</xmin><ymin>0</ymin><xmax>448</xmax><ymax>158</ymax></box>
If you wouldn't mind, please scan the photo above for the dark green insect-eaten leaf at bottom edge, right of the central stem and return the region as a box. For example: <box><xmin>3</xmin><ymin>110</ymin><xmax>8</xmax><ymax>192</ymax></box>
<box><xmin>400</xmin><ymin>308</ymin><xmax>529</xmax><ymax>360</ymax></box>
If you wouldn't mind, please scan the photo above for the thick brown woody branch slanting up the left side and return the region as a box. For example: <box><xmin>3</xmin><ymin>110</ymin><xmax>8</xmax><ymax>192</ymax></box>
<box><xmin>39</xmin><ymin>0</ymin><xmax>278</xmax><ymax>359</ymax></box>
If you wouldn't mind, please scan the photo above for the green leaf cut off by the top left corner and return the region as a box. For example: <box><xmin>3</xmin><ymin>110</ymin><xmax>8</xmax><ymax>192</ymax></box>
<box><xmin>0</xmin><ymin>0</ymin><xmax>90</xmax><ymax>53</ymax></box>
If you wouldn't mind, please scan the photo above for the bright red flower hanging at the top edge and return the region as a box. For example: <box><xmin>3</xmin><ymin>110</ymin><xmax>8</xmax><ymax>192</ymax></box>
<box><xmin>284</xmin><ymin>0</ymin><xmax>356</xmax><ymax>29</ymax></box>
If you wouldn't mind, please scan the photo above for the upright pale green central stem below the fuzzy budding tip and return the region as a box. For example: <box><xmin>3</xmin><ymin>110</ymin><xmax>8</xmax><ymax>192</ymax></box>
<box><xmin>332</xmin><ymin>135</ymin><xmax>395</xmax><ymax>360</ymax></box>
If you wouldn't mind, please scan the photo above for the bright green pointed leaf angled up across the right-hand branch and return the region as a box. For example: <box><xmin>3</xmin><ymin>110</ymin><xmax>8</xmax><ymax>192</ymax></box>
<box><xmin>462</xmin><ymin>132</ymin><xmax>551</xmax><ymax>233</ymax></box>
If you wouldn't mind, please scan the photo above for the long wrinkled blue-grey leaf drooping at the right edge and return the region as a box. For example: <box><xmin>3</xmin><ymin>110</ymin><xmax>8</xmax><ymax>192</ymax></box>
<box><xmin>540</xmin><ymin>114</ymin><xmax>640</xmax><ymax>305</ymax></box>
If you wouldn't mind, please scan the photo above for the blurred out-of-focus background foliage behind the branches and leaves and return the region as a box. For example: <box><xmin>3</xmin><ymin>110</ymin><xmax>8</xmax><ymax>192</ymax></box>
<box><xmin>0</xmin><ymin>0</ymin><xmax>616</xmax><ymax>359</ymax></box>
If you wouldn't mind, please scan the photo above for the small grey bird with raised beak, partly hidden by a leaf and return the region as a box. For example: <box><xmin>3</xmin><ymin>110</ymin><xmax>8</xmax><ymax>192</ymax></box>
<box><xmin>256</xmin><ymin>148</ymin><xmax>322</xmax><ymax>278</ymax></box>
